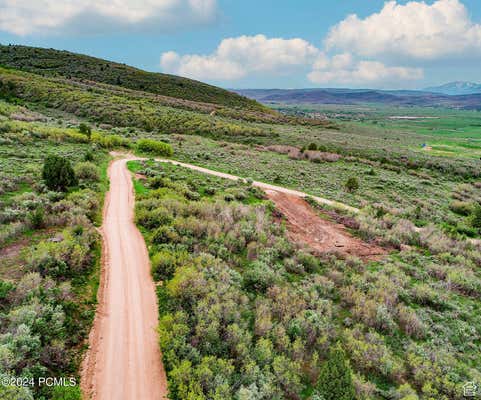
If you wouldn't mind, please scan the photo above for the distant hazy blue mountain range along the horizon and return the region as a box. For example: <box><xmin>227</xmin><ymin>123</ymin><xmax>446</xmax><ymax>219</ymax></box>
<box><xmin>234</xmin><ymin>88</ymin><xmax>481</xmax><ymax>110</ymax></box>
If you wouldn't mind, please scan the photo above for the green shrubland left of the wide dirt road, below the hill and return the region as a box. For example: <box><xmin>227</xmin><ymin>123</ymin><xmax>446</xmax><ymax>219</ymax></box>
<box><xmin>0</xmin><ymin>102</ymin><xmax>112</xmax><ymax>400</ymax></box>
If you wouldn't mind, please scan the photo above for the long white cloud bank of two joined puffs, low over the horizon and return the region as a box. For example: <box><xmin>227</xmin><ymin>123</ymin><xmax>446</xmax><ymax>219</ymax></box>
<box><xmin>160</xmin><ymin>35</ymin><xmax>423</xmax><ymax>85</ymax></box>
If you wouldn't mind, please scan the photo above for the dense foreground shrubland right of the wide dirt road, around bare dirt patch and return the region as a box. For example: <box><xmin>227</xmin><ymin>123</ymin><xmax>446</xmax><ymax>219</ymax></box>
<box><xmin>130</xmin><ymin>162</ymin><xmax>481</xmax><ymax>400</ymax></box>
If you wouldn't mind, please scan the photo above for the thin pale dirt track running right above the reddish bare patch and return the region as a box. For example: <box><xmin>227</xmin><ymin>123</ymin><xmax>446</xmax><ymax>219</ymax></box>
<box><xmin>155</xmin><ymin>158</ymin><xmax>359</xmax><ymax>213</ymax></box>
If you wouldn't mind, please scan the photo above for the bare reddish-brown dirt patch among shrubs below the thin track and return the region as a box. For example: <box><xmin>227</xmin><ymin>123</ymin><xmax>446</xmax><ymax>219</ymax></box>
<box><xmin>266</xmin><ymin>190</ymin><xmax>387</xmax><ymax>260</ymax></box>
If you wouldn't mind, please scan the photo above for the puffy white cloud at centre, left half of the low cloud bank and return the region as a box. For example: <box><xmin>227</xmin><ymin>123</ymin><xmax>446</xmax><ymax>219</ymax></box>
<box><xmin>160</xmin><ymin>35</ymin><xmax>319</xmax><ymax>80</ymax></box>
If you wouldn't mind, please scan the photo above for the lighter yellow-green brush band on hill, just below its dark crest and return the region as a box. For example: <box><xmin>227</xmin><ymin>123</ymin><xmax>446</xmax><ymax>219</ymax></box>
<box><xmin>0</xmin><ymin>68</ymin><xmax>270</xmax><ymax>136</ymax></box>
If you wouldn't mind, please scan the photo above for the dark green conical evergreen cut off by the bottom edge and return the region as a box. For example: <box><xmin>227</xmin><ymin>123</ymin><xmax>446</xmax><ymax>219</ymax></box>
<box><xmin>316</xmin><ymin>345</ymin><xmax>356</xmax><ymax>400</ymax></box>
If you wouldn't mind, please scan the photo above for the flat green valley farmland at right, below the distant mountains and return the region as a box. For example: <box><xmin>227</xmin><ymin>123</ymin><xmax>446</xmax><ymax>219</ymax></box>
<box><xmin>274</xmin><ymin>104</ymin><xmax>481</xmax><ymax>159</ymax></box>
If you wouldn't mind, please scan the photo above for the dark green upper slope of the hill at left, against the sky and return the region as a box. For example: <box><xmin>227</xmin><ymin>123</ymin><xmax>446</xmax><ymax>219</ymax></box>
<box><xmin>0</xmin><ymin>45</ymin><xmax>269</xmax><ymax>112</ymax></box>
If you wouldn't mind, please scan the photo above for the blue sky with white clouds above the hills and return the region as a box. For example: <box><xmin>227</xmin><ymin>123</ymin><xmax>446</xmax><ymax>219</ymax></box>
<box><xmin>0</xmin><ymin>0</ymin><xmax>481</xmax><ymax>89</ymax></box>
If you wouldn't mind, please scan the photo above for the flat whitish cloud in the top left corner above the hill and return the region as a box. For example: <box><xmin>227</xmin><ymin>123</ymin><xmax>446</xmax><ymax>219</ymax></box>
<box><xmin>0</xmin><ymin>0</ymin><xmax>217</xmax><ymax>35</ymax></box>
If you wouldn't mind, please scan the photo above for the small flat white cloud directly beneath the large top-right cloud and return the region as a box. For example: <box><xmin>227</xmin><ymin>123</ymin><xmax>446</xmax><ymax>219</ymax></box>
<box><xmin>308</xmin><ymin>54</ymin><xmax>424</xmax><ymax>87</ymax></box>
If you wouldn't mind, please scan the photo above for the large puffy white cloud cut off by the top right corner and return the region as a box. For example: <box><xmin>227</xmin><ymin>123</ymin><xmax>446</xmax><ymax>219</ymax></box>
<box><xmin>325</xmin><ymin>0</ymin><xmax>481</xmax><ymax>59</ymax></box>
